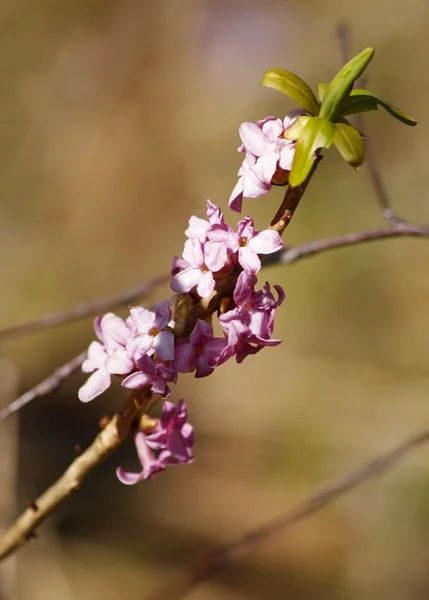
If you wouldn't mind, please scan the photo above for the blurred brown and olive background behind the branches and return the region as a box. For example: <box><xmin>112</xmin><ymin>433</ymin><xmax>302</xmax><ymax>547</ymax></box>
<box><xmin>0</xmin><ymin>0</ymin><xmax>429</xmax><ymax>600</ymax></box>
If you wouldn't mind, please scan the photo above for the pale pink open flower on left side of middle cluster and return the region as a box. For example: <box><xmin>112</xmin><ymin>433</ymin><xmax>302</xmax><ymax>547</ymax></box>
<box><xmin>170</xmin><ymin>238</ymin><xmax>227</xmax><ymax>298</ymax></box>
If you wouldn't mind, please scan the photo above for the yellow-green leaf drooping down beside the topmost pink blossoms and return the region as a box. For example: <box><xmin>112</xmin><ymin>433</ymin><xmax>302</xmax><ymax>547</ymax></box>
<box><xmin>289</xmin><ymin>117</ymin><xmax>335</xmax><ymax>187</ymax></box>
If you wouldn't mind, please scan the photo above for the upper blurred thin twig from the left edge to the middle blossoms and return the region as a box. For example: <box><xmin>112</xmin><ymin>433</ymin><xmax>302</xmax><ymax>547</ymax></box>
<box><xmin>0</xmin><ymin>275</ymin><xmax>170</xmax><ymax>340</ymax></box>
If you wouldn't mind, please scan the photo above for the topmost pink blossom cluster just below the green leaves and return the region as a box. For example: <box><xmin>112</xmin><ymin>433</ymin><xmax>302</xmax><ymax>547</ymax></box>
<box><xmin>229</xmin><ymin>109</ymin><xmax>305</xmax><ymax>212</ymax></box>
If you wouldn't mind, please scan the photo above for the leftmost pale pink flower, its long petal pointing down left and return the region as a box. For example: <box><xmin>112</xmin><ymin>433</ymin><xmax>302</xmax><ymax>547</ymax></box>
<box><xmin>78</xmin><ymin>313</ymin><xmax>134</xmax><ymax>402</ymax></box>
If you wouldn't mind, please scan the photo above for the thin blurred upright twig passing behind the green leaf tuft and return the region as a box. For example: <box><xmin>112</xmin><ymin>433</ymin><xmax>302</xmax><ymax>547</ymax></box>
<box><xmin>337</xmin><ymin>23</ymin><xmax>404</xmax><ymax>225</ymax></box>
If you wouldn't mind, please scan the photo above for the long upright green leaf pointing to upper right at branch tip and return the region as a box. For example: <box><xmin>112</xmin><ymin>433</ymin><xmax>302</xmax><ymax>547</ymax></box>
<box><xmin>319</xmin><ymin>48</ymin><xmax>374</xmax><ymax>121</ymax></box>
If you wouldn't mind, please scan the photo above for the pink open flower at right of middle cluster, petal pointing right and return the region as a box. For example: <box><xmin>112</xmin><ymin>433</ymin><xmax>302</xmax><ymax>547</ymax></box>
<box><xmin>207</xmin><ymin>217</ymin><xmax>283</xmax><ymax>273</ymax></box>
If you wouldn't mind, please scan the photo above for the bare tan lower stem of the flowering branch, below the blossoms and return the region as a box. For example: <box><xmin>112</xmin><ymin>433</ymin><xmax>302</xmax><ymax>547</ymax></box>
<box><xmin>0</xmin><ymin>388</ymin><xmax>151</xmax><ymax>560</ymax></box>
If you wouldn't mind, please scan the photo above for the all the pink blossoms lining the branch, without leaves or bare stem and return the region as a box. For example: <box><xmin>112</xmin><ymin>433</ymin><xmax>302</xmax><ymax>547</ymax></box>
<box><xmin>79</xmin><ymin>113</ymin><xmax>294</xmax><ymax>484</ymax></box>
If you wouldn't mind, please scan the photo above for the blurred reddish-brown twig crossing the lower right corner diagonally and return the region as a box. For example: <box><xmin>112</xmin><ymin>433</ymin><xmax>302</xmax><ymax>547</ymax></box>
<box><xmin>145</xmin><ymin>429</ymin><xmax>429</xmax><ymax>600</ymax></box>
